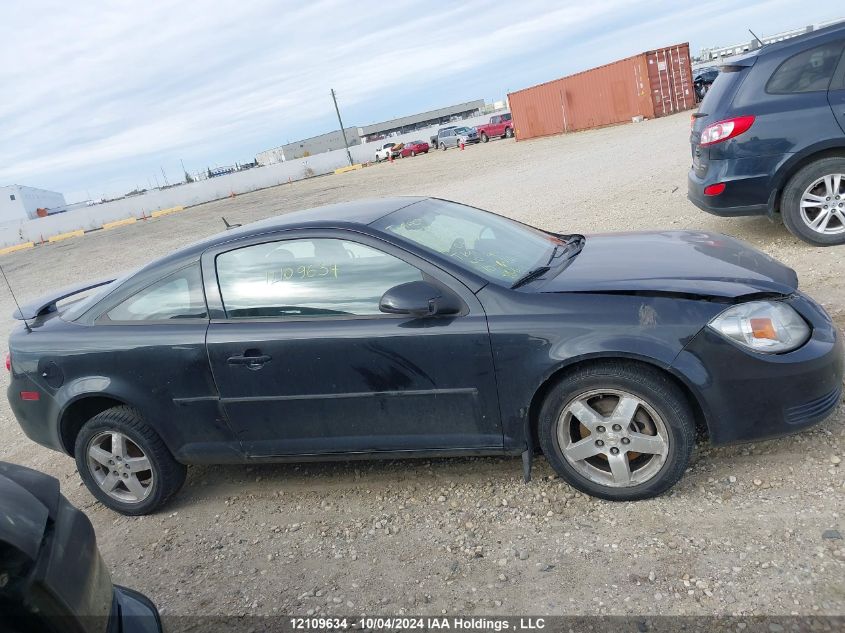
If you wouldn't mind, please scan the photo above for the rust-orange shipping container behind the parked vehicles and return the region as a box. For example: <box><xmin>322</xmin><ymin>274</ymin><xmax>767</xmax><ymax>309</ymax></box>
<box><xmin>508</xmin><ymin>44</ymin><xmax>695</xmax><ymax>140</ymax></box>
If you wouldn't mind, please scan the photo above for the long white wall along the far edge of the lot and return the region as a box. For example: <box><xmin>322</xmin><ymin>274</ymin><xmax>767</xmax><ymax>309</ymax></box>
<box><xmin>0</xmin><ymin>114</ymin><xmax>502</xmax><ymax>247</ymax></box>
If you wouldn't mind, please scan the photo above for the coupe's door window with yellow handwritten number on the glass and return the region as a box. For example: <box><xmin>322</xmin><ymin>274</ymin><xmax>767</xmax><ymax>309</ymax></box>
<box><xmin>216</xmin><ymin>238</ymin><xmax>423</xmax><ymax>319</ymax></box>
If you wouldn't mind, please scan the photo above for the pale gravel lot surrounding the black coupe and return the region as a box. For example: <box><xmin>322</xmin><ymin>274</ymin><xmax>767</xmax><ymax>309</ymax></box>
<box><xmin>0</xmin><ymin>114</ymin><xmax>845</xmax><ymax>615</ymax></box>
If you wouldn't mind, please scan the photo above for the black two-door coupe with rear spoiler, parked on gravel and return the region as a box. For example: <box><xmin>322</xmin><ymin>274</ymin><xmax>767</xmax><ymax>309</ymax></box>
<box><xmin>8</xmin><ymin>198</ymin><xmax>843</xmax><ymax>512</ymax></box>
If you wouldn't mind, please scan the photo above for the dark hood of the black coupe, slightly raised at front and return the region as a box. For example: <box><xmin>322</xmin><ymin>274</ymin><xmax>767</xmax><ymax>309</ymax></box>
<box><xmin>533</xmin><ymin>231</ymin><xmax>798</xmax><ymax>298</ymax></box>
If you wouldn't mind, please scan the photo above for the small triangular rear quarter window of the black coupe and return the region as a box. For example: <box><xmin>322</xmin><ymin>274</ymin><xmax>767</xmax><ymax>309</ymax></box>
<box><xmin>106</xmin><ymin>264</ymin><xmax>208</xmax><ymax>321</ymax></box>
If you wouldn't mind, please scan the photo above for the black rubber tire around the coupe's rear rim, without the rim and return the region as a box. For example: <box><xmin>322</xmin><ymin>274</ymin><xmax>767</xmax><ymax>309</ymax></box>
<box><xmin>74</xmin><ymin>410</ymin><xmax>181</xmax><ymax>515</ymax></box>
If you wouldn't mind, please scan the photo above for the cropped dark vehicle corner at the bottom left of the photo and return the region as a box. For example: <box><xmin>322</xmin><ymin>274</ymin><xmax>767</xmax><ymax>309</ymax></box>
<box><xmin>0</xmin><ymin>462</ymin><xmax>162</xmax><ymax>633</ymax></box>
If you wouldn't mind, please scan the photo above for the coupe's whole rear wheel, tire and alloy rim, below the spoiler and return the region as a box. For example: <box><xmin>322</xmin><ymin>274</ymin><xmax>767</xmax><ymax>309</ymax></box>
<box><xmin>74</xmin><ymin>406</ymin><xmax>187</xmax><ymax>515</ymax></box>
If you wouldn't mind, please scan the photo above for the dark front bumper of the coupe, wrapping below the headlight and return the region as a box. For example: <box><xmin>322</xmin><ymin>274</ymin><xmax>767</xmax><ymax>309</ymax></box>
<box><xmin>672</xmin><ymin>293</ymin><xmax>845</xmax><ymax>445</ymax></box>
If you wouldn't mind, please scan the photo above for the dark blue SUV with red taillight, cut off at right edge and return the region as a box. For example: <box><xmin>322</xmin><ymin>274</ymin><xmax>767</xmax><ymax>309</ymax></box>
<box><xmin>688</xmin><ymin>24</ymin><xmax>845</xmax><ymax>246</ymax></box>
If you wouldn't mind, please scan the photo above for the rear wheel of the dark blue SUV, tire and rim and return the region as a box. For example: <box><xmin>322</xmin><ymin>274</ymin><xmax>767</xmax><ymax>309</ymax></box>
<box><xmin>781</xmin><ymin>158</ymin><xmax>845</xmax><ymax>246</ymax></box>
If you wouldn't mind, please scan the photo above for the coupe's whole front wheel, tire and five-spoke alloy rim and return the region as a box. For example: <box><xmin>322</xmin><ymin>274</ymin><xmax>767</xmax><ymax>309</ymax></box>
<box><xmin>538</xmin><ymin>361</ymin><xmax>695</xmax><ymax>501</ymax></box>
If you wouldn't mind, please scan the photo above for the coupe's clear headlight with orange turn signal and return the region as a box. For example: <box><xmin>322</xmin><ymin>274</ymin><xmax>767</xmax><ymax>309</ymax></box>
<box><xmin>708</xmin><ymin>301</ymin><xmax>810</xmax><ymax>353</ymax></box>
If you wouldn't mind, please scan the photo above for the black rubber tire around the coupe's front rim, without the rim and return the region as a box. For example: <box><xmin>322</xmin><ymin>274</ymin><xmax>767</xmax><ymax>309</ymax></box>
<box><xmin>538</xmin><ymin>362</ymin><xmax>695</xmax><ymax>501</ymax></box>
